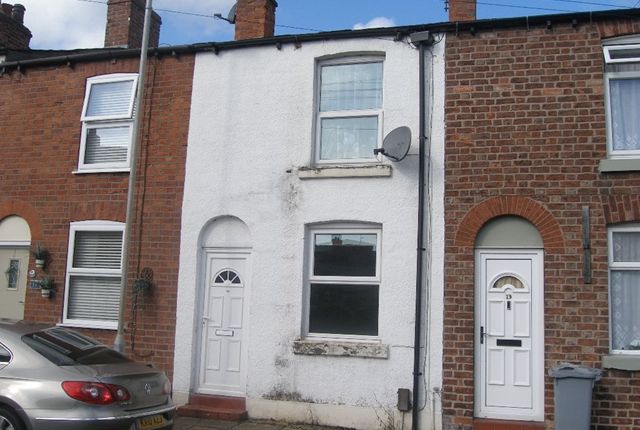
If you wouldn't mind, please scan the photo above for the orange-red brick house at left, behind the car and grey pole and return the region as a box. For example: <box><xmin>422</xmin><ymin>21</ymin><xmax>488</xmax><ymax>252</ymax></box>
<box><xmin>0</xmin><ymin>0</ymin><xmax>194</xmax><ymax>373</ymax></box>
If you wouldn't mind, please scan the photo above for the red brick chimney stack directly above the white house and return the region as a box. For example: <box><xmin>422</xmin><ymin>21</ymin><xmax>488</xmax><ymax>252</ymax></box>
<box><xmin>235</xmin><ymin>0</ymin><xmax>278</xmax><ymax>40</ymax></box>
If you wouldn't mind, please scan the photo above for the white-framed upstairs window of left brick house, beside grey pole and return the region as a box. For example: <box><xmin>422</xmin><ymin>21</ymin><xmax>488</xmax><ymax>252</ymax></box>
<box><xmin>78</xmin><ymin>73</ymin><xmax>138</xmax><ymax>172</ymax></box>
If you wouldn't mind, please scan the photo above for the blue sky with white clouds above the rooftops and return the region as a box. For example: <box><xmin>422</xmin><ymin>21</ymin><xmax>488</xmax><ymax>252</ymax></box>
<box><xmin>11</xmin><ymin>0</ymin><xmax>640</xmax><ymax>49</ymax></box>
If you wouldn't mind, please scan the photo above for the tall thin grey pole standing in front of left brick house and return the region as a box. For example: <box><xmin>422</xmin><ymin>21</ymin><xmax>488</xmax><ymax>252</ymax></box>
<box><xmin>113</xmin><ymin>0</ymin><xmax>153</xmax><ymax>352</ymax></box>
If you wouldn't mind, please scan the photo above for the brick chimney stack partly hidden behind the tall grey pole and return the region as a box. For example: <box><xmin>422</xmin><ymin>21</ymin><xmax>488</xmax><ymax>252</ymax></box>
<box><xmin>104</xmin><ymin>0</ymin><xmax>162</xmax><ymax>49</ymax></box>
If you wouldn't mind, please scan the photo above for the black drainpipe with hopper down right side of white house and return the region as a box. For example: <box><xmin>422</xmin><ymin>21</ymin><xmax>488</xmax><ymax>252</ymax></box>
<box><xmin>410</xmin><ymin>31</ymin><xmax>432</xmax><ymax>430</ymax></box>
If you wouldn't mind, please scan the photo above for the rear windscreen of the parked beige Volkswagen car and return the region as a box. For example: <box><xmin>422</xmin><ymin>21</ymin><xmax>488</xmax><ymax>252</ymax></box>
<box><xmin>22</xmin><ymin>327</ymin><xmax>131</xmax><ymax>366</ymax></box>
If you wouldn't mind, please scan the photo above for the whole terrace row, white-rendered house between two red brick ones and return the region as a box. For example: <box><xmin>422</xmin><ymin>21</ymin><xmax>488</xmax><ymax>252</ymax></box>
<box><xmin>0</xmin><ymin>0</ymin><xmax>640</xmax><ymax>430</ymax></box>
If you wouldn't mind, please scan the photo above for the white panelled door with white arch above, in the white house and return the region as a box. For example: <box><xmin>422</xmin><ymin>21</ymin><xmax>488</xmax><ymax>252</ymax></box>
<box><xmin>193</xmin><ymin>216</ymin><xmax>251</xmax><ymax>397</ymax></box>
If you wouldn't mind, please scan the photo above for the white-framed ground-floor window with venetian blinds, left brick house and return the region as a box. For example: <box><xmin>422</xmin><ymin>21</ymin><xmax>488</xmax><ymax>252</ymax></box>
<box><xmin>63</xmin><ymin>221</ymin><xmax>124</xmax><ymax>329</ymax></box>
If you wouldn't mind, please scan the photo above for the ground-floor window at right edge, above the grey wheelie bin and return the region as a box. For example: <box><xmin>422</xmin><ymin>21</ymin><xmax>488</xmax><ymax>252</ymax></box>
<box><xmin>609</xmin><ymin>224</ymin><xmax>640</xmax><ymax>354</ymax></box>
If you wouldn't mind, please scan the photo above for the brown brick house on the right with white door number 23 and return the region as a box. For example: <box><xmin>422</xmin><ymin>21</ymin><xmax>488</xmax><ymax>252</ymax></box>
<box><xmin>443</xmin><ymin>2</ymin><xmax>640</xmax><ymax>429</ymax></box>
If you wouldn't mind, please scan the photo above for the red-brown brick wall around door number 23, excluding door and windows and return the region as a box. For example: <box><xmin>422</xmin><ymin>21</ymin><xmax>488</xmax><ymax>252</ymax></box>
<box><xmin>443</xmin><ymin>21</ymin><xmax>640</xmax><ymax>429</ymax></box>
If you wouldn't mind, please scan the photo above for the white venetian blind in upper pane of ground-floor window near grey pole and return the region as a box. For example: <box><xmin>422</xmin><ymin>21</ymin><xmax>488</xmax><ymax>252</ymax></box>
<box><xmin>73</xmin><ymin>231</ymin><xmax>122</xmax><ymax>270</ymax></box>
